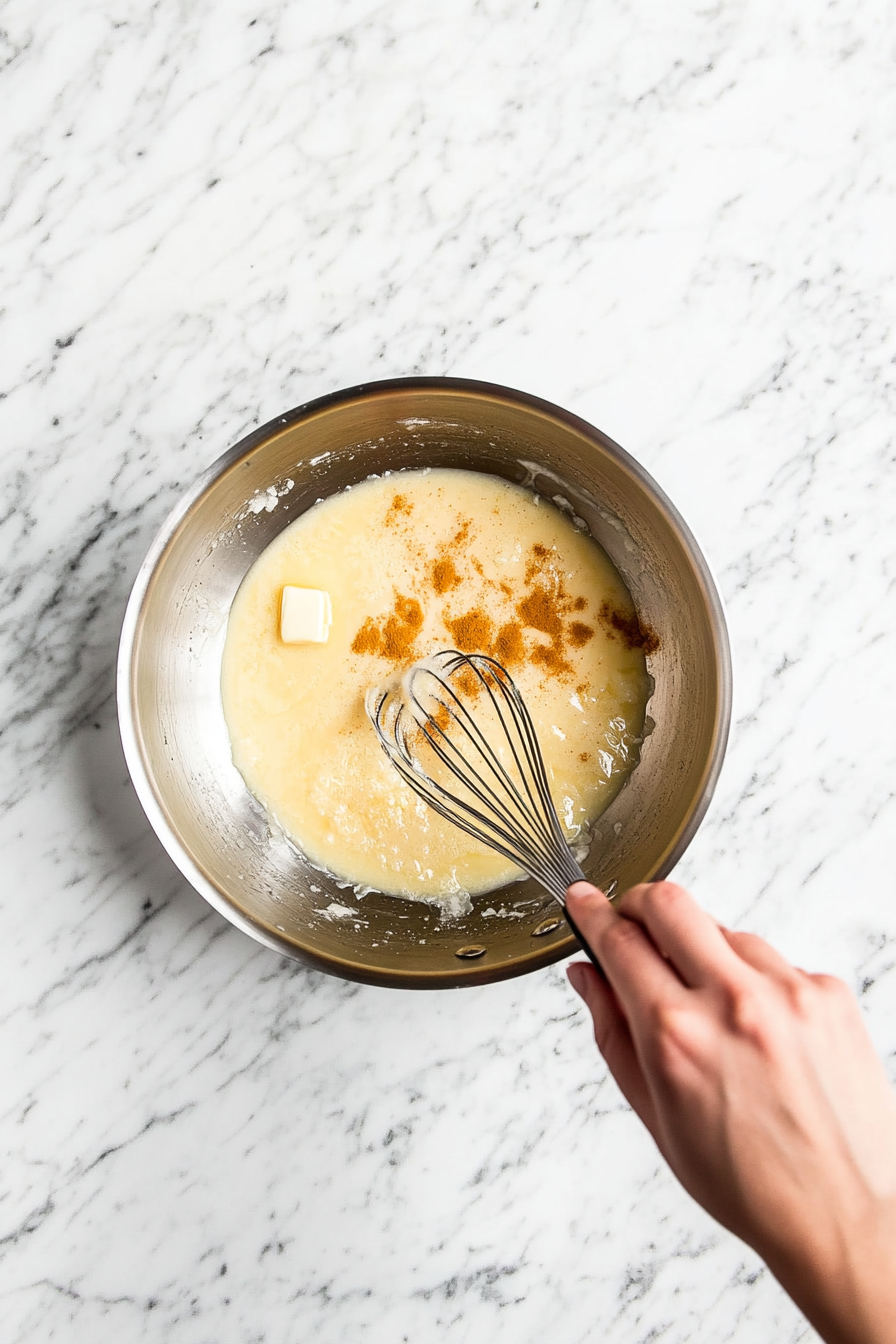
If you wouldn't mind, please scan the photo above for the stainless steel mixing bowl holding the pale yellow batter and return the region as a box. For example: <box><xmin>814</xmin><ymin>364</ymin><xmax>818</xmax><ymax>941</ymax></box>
<box><xmin>118</xmin><ymin>378</ymin><xmax>731</xmax><ymax>989</ymax></box>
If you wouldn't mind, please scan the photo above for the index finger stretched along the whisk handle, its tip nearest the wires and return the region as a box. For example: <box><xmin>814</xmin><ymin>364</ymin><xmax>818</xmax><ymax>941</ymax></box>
<box><xmin>567</xmin><ymin>882</ymin><xmax>685</xmax><ymax>1019</ymax></box>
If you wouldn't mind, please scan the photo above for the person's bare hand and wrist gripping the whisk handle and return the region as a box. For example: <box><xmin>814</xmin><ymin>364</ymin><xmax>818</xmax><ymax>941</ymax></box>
<box><xmin>567</xmin><ymin>882</ymin><xmax>896</xmax><ymax>1344</ymax></box>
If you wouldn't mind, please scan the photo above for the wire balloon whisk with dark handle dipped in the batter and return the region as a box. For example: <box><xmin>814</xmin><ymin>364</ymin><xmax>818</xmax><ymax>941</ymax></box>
<box><xmin>365</xmin><ymin>649</ymin><xmax>600</xmax><ymax>970</ymax></box>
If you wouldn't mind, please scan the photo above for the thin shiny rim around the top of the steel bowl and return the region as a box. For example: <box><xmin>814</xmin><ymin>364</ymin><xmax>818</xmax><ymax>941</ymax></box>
<box><xmin>116</xmin><ymin>375</ymin><xmax>733</xmax><ymax>989</ymax></box>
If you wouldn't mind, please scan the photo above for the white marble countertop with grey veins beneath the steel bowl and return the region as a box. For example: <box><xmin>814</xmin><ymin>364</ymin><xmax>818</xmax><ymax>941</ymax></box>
<box><xmin>0</xmin><ymin>0</ymin><xmax>896</xmax><ymax>1344</ymax></box>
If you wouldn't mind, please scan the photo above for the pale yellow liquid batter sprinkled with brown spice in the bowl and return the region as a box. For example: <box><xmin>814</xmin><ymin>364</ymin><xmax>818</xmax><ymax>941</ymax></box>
<box><xmin>222</xmin><ymin>469</ymin><xmax>656</xmax><ymax>899</ymax></box>
